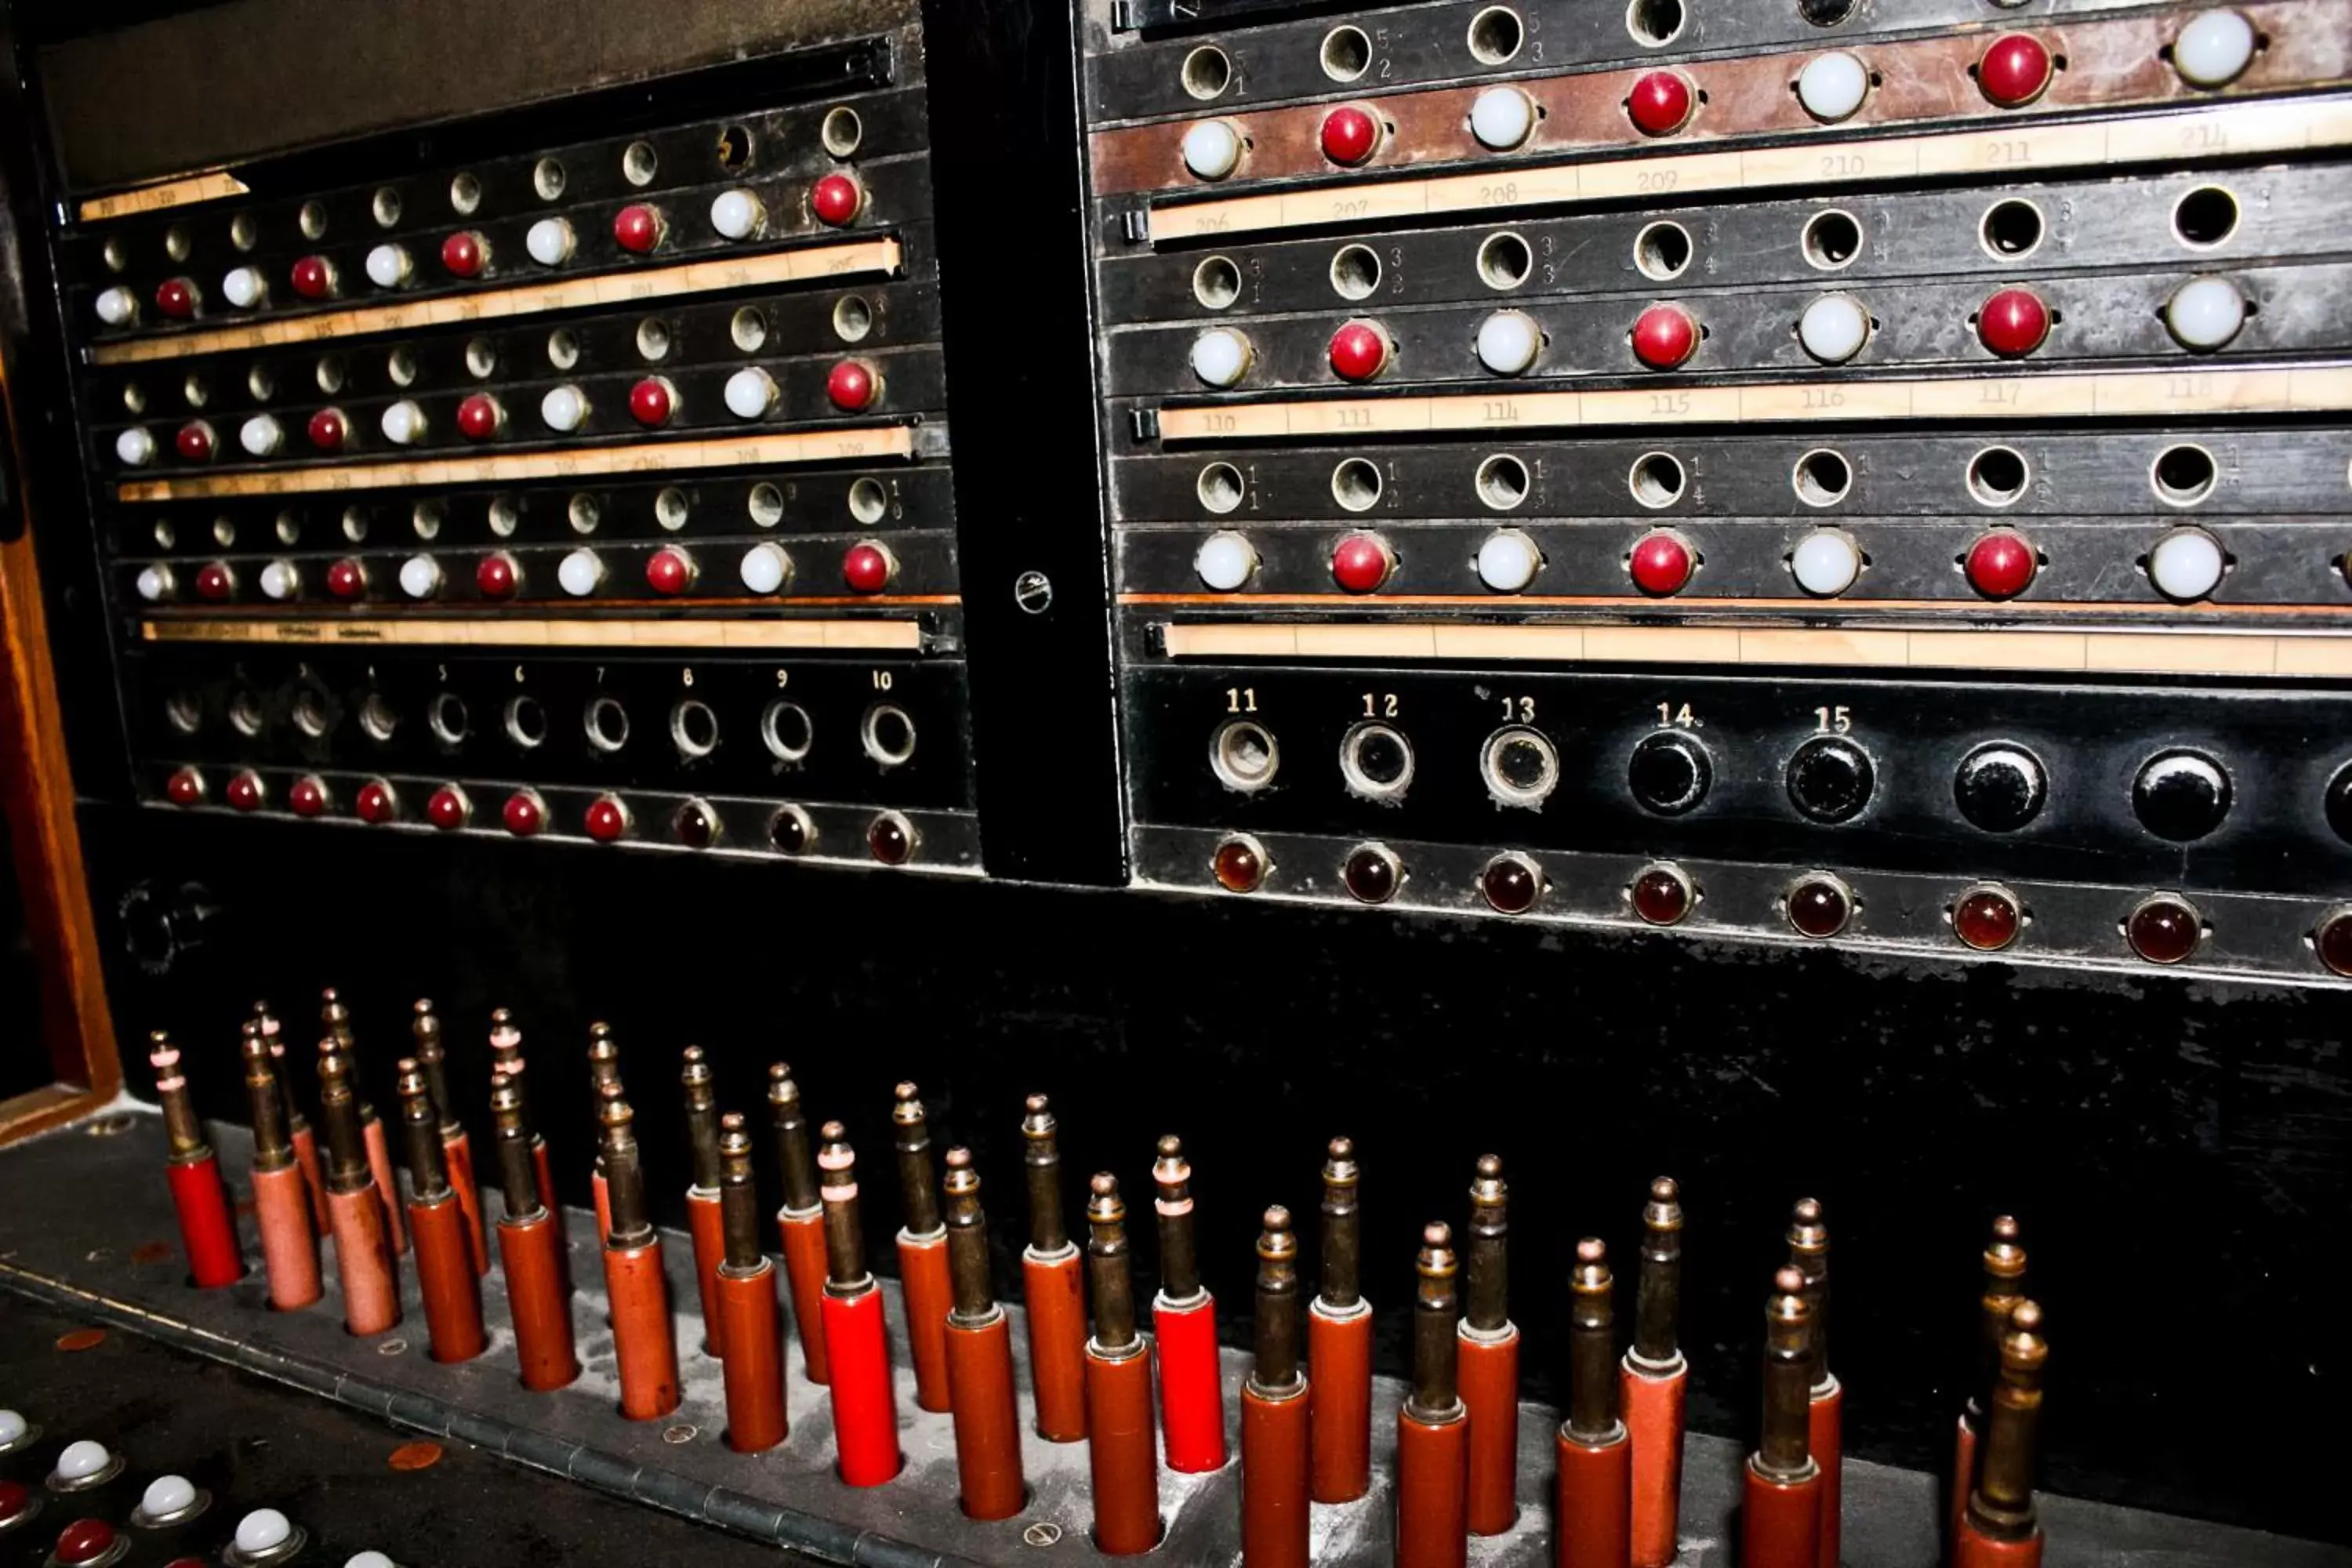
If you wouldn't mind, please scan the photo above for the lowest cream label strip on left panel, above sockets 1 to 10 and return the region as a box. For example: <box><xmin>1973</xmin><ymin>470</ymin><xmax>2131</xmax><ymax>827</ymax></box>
<box><xmin>139</xmin><ymin>611</ymin><xmax>927</xmax><ymax>654</ymax></box>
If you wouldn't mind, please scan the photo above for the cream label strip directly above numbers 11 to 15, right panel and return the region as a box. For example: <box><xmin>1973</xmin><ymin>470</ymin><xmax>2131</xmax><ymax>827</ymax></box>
<box><xmin>1160</xmin><ymin>621</ymin><xmax>2352</xmax><ymax>677</ymax></box>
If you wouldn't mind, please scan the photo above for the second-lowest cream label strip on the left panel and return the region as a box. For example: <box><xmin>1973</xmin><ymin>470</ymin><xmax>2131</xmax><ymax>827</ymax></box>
<box><xmin>115</xmin><ymin>426</ymin><xmax>915</xmax><ymax>501</ymax></box>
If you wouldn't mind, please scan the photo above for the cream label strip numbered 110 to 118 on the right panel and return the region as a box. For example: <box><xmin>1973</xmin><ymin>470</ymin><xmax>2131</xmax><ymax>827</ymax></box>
<box><xmin>1160</xmin><ymin>365</ymin><xmax>2352</xmax><ymax>442</ymax></box>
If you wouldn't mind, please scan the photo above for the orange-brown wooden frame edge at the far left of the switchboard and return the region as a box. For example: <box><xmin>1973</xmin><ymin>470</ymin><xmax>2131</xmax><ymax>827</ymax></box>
<box><xmin>0</xmin><ymin>378</ymin><xmax>122</xmax><ymax>1142</ymax></box>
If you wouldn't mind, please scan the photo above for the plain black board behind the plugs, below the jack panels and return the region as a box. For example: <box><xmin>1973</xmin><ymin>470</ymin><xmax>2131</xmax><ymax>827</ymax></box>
<box><xmin>85</xmin><ymin>808</ymin><xmax>2352</xmax><ymax>1540</ymax></box>
